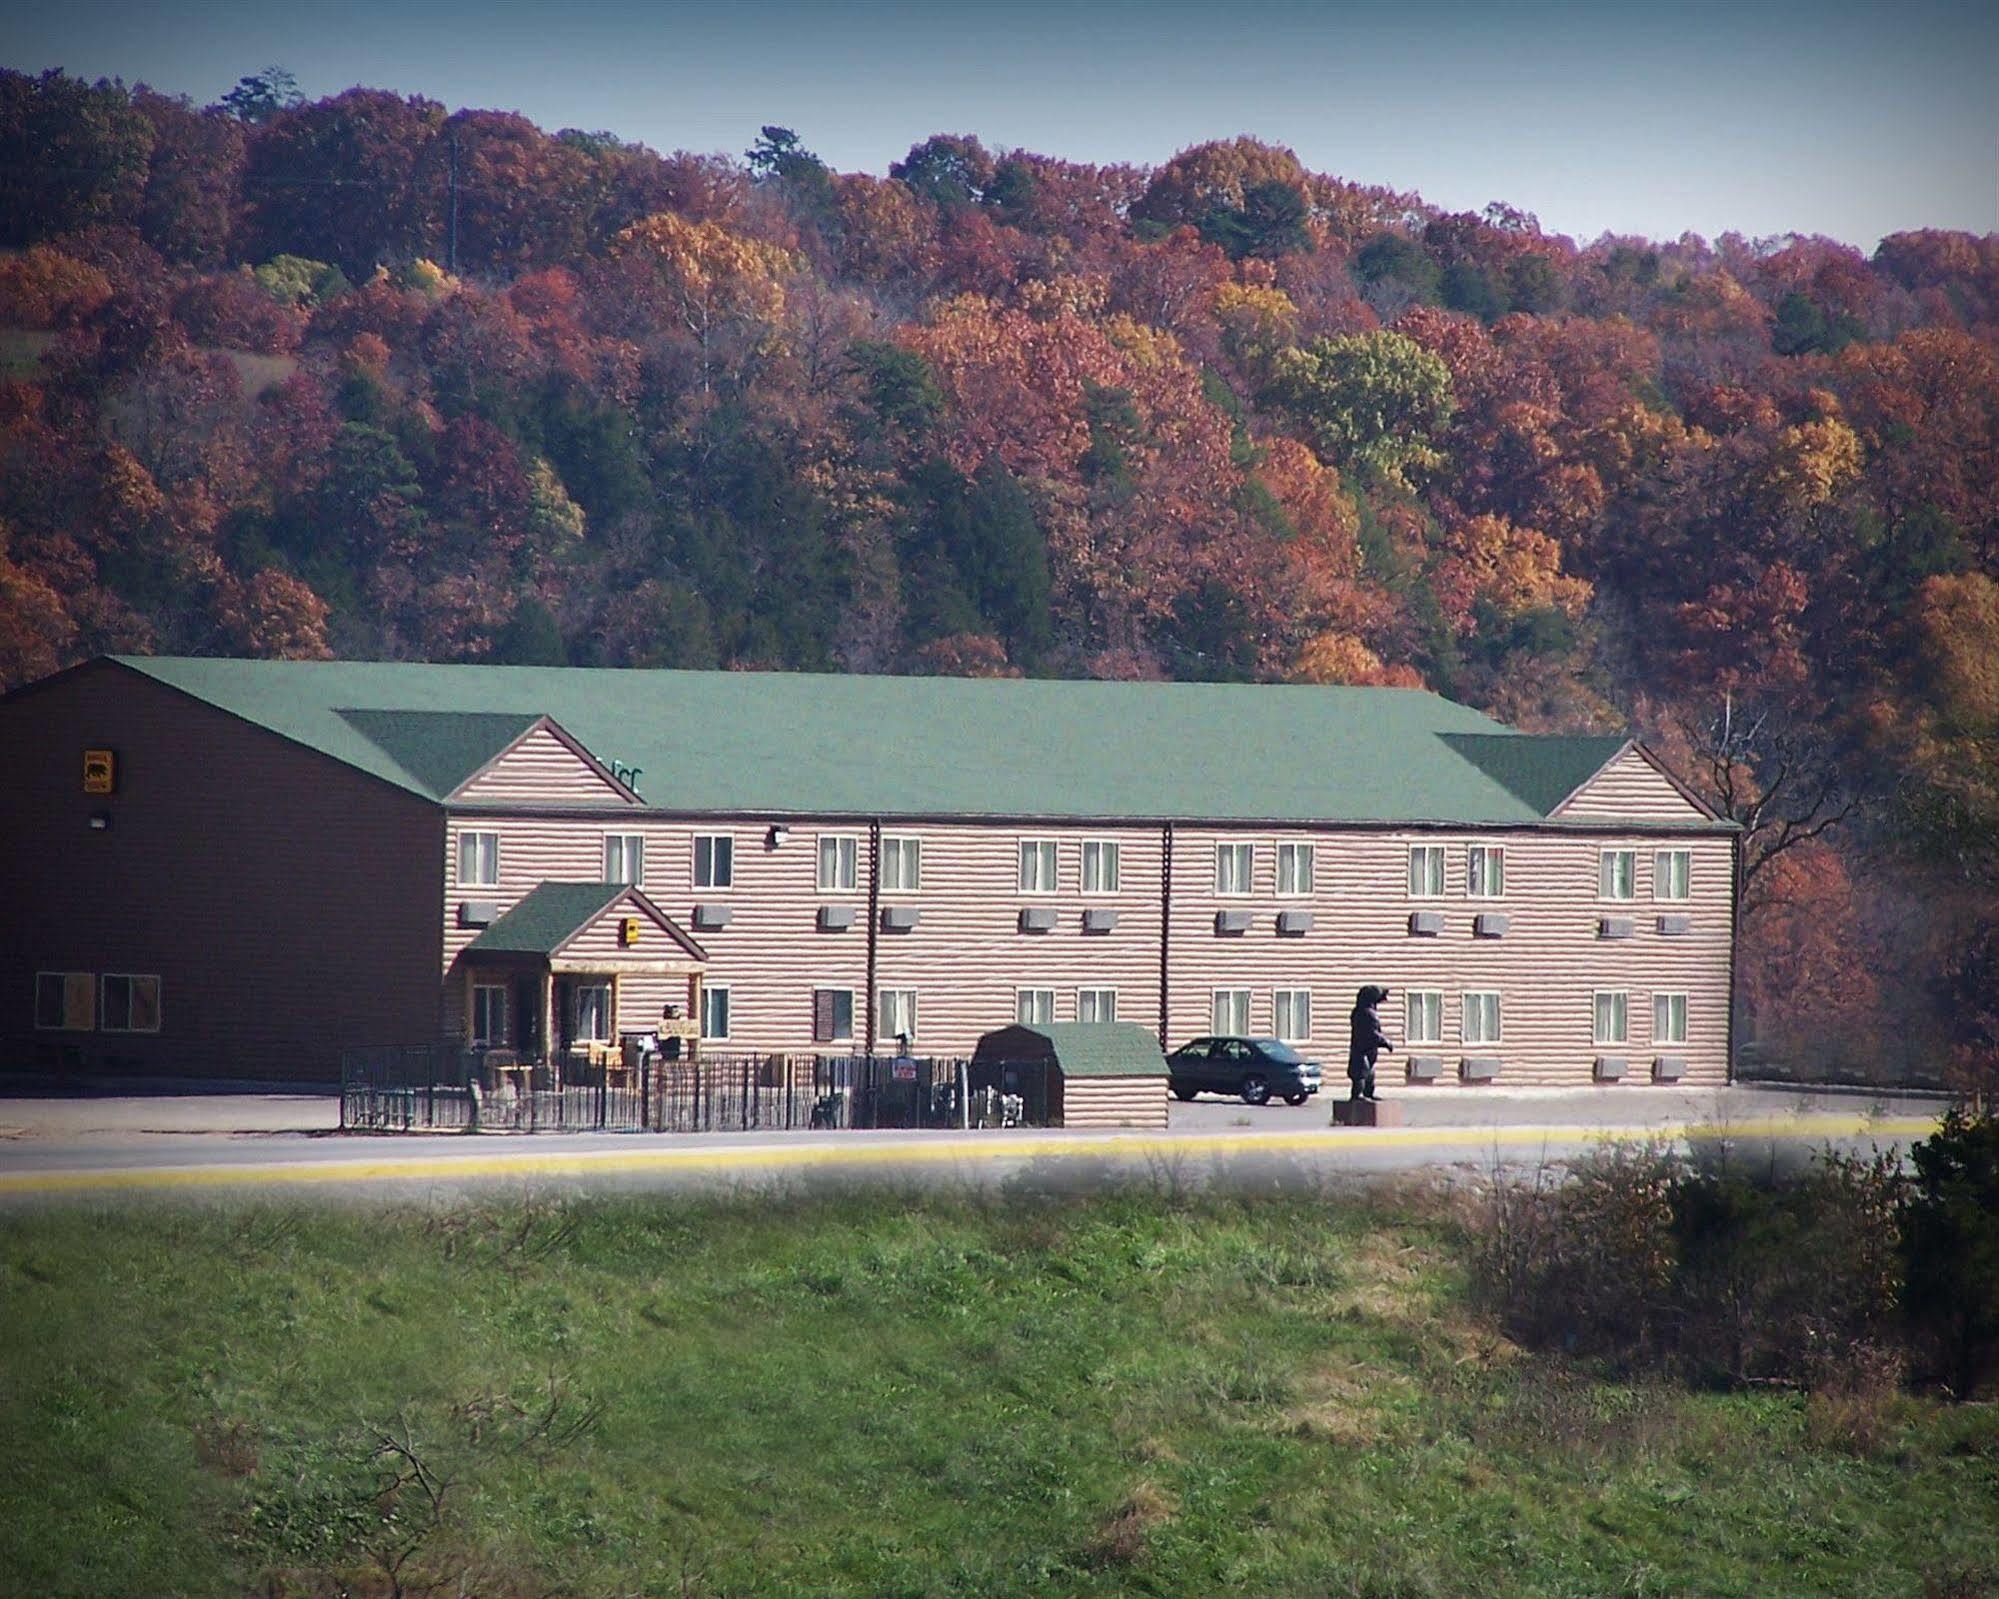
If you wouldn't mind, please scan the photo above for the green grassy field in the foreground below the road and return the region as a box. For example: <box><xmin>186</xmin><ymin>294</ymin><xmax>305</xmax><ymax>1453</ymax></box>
<box><xmin>0</xmin><ymin>1193</ymin><xmax>1999</xmax><ymax>1599</ymax></box>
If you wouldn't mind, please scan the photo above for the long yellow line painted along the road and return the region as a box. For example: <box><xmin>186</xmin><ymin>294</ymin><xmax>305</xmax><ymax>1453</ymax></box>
<box><xmin>0</xmin><ymin>1115</ymin><xmax>1937</xmax><ymax>1197</ymax></box>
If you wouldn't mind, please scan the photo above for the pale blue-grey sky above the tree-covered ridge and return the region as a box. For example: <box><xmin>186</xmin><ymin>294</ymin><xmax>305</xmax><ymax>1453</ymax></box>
<box><xmin>0</xmin><ymin>0</ymin><xmax>1999</xmax><ymax>250</ymax></box>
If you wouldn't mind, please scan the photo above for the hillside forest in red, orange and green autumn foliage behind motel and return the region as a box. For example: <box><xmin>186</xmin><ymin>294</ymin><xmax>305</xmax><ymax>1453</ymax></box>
<box><xmin>0</xmin><ymin>74</ymin><xmax>1999</xmax><ymax>1067</ymax></box>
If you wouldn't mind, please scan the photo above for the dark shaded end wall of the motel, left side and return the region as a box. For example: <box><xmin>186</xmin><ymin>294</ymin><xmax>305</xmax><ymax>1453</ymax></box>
<box><xmin>0</xmin><ymin>662</ymin><xmax>444</xmax><ymax>1081</ymax></box>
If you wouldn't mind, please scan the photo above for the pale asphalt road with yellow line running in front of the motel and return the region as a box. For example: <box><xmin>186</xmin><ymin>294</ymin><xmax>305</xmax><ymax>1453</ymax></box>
<box><xmin>0</xmin><ymin>1087</ymin><xmax>1941</xmax><ymax>1203</ymax></box>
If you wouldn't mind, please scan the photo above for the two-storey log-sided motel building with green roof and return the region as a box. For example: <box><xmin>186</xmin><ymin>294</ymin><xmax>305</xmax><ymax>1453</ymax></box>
<box><xmin>0</xmin><ymin>658</ymin><xmax>1737</xmax><ymax>1093</ymax></box>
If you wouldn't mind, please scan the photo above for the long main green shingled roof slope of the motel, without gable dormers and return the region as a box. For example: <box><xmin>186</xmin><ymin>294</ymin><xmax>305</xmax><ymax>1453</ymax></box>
<box><xmin>105</xmin><ymin>656</ymin><xmax>1711</xmax><ymax>825</ymax></box>
